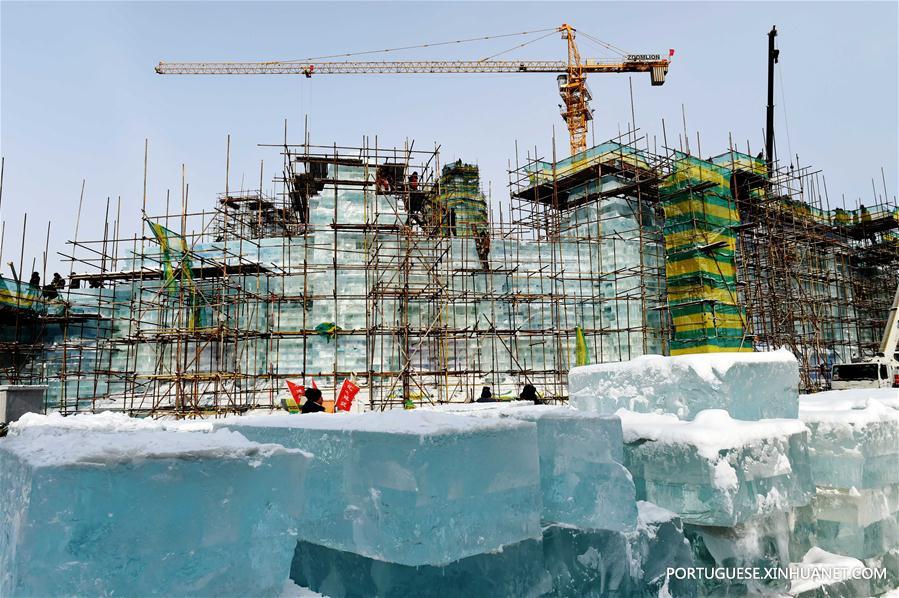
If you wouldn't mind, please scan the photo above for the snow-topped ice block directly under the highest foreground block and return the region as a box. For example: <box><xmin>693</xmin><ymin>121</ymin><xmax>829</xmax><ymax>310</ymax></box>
<box><xmin>618</xmin><ymin>409</ymin><xmax>814</xmax><ymax>526</ymax></box>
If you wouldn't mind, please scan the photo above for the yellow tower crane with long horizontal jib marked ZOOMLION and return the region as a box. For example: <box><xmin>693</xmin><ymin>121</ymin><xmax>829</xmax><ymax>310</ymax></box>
<box><xmin>156</xmin><ymin>24</ymin><xmax>674</xmax><ymax>155</ymax></box>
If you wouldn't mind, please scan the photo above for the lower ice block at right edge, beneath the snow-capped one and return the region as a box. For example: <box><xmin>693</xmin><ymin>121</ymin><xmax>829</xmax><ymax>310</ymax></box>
<box><xmin>812</xmin><ymin>485</ymin><xmax>899</xmax><ymax>559</ymax></box>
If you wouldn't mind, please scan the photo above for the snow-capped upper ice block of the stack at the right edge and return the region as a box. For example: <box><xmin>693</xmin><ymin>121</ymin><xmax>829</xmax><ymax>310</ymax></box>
<box><xmin>799</xmin><ymin>388</ymin><xmax>899</xmax><ymax>489</ymax></box>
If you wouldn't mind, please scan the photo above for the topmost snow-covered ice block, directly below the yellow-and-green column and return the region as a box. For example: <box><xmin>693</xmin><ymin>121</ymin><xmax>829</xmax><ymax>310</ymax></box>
<box><xmin>568</xmin><ymin>349</ymin><xmax>799</xmax><ymax>420</ymax></box>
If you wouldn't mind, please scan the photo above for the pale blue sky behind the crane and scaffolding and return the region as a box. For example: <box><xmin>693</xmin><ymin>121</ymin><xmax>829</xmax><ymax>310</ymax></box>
<box><xmin>0</xmin><ymin>1</ymin><xmax>899</xmax><ymax>276</ymax></box>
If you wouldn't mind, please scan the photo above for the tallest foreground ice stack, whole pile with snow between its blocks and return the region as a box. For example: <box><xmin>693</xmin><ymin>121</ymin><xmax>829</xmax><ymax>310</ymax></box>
<box><xmin>569</xmin><ymin>351</ymin><xmax>814</xmax><ymax>594</ymax></box>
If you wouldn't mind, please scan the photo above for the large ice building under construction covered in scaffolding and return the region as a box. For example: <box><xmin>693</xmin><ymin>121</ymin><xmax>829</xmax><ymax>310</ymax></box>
<box><xmin>0</xmin><ymin>138</ymin><xmax>899</xmax><ymax>415</ymax></box>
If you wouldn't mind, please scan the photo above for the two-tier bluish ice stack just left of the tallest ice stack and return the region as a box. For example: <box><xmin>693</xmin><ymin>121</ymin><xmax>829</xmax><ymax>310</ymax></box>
<box><xmin>432</xmin><ymin>403</ymin><xmax>692</xmax><ymax>596</ymax></box>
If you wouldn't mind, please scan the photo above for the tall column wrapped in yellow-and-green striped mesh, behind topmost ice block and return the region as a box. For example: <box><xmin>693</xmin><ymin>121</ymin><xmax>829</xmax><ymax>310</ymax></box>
<box><xmin>659</xmin><ymin>154</ymin><xmax>753</xmax><ymax>355</ymax></box>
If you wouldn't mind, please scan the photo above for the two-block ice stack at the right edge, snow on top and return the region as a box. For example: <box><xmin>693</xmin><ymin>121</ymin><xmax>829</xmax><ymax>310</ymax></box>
<box><xmin>799</xmin><ymin>389</ymin><xmax>899</xmax><ymax>578</ymax></box>
